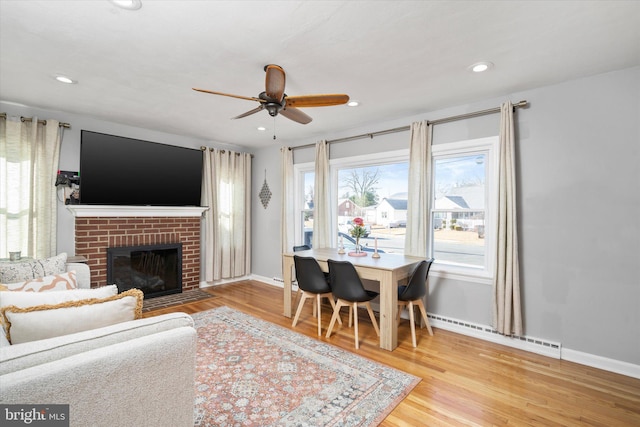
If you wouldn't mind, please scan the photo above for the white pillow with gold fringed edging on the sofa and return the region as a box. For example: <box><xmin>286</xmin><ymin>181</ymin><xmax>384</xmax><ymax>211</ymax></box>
<box><xmin>0</xmin><ymin>289</ymin><xmax>144</xmax><ymax>344</ymax></box>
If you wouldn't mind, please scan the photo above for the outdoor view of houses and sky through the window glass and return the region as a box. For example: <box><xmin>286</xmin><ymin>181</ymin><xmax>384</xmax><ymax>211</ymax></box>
<box><xmin>299</xmin><ymin>145</ymin><xmax>487</xmax><ymax>268</ymax></box>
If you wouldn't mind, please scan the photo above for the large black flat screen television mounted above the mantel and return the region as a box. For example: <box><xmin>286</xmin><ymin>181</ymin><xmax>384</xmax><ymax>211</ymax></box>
<box><xmin>80</xmin><ymin>130</ymin><xmax>202</xmax><ymax>206</ymax></box>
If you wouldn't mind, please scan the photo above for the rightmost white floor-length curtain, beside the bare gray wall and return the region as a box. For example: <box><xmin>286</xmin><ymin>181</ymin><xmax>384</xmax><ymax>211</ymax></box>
<box><xmin>493</xmin><ymin>102</ymin><xmax>523</xmax><ymax>336</ymax></box>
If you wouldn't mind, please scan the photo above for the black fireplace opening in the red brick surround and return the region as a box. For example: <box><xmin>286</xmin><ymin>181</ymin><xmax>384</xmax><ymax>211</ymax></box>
<box><xmin>107</xmin><ymin>243</ymin><xmax>182</xmax><ymax>298</ymax></box>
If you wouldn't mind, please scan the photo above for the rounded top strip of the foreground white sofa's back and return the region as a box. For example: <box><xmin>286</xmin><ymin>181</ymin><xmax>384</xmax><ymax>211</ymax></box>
<box><xmin>0</xmin><ymin>313</ymin><xmax>193</xmax><ymax>375</ymax></box>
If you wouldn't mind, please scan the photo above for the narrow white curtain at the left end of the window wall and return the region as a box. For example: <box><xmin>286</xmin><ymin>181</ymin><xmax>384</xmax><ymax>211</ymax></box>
<box><xmin>280</xmin><ymin>147</ymin><xmax>295</xmax><ymax>253</ymax></box>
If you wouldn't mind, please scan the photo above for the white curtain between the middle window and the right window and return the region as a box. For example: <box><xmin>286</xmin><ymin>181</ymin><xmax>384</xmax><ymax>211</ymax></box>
<box><xmin>404</xmin><ymin>120</ymin><xmax>433</xmax><ymax>258</ymax></box>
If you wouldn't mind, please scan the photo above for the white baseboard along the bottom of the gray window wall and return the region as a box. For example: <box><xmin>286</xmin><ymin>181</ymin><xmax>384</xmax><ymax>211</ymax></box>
<box><xmin>250</xmin><ymin>275</ymin><xmax>640</xmax><ymax>379</ymax></box>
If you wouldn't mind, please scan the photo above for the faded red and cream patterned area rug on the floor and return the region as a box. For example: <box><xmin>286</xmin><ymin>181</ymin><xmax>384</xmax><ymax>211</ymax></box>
<box><xmin>193</xmin><ymin>307</ymin><xmax>420</xmax><ymax>427</ymax></box>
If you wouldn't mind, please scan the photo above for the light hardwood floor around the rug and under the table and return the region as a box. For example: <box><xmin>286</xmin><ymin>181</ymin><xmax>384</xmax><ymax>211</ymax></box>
<box><xmin>145</xmin><ymin>281</ymin><xmax>640</xmax><ymax>427</ymax></box>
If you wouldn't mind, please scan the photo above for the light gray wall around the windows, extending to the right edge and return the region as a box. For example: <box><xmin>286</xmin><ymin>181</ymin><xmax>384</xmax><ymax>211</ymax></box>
<box><xmin>252</xmin><ymin>67</ymin><xmax>640</xmax><ymax>364</ymax></box>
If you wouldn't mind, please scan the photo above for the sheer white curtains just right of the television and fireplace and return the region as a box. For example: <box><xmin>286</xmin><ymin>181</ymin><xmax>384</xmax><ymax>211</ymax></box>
<box><xmin>203</xmin><ymin>149</ymin><xmax>251</xmax><ymax>282</ymax></box>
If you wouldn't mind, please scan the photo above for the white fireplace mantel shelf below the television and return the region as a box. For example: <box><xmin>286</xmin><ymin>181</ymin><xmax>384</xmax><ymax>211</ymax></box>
<box><xmin>67</xmin><ymin>205</ymin><xmax>209</xmax><ymax>218</ymax></box>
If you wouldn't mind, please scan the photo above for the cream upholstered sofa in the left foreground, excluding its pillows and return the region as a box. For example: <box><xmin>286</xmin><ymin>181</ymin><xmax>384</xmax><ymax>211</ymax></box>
<box><xmin>0</xmin><ymin>264</ymin><xmax>196</xmax><ymax>427</ymax></box>
